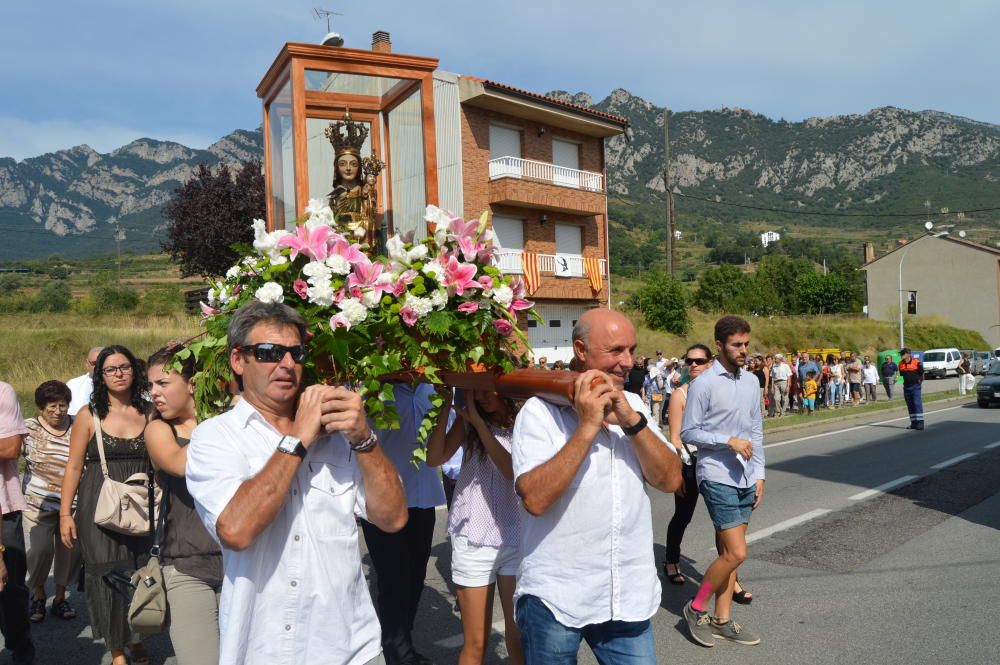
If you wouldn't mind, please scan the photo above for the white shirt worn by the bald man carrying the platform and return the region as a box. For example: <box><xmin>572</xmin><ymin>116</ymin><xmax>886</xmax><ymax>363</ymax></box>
<box><xmin>512</xmin><ymin>392</ymin><xmax>673</xmax><ymax>628</ymax></box>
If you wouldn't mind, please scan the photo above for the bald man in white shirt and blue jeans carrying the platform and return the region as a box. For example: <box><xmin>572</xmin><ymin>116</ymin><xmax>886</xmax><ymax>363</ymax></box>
<box><xmin>512</xmin><ymin>309</ymin><xmax>681</xmax><ymax>665</ymax></box>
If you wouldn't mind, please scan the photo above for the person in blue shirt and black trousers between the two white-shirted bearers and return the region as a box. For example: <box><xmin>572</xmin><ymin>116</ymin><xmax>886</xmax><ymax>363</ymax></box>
<box><xmin>361</xmin><ymin>383</ymin><xmax>445</xmax><ymax>665</ymax></box>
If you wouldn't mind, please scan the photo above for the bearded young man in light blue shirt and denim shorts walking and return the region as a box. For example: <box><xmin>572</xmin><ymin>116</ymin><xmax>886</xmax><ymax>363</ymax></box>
<box><xmin>681</xmin><ymin>316</ymin><xmax>764</xmax><ymax>647</ymax></box>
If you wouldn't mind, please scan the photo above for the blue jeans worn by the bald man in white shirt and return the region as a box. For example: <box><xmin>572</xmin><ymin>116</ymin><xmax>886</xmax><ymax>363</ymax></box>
<box><xmin>515</xmin><ymin>596</ymin><xmax>656</xmax><ymax>665</ymax></box>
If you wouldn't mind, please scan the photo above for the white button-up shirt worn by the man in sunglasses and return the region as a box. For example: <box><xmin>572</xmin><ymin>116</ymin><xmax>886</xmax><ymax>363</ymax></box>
<box><xmin>186</xmin><ymin>399</ymin><xmax>381</xmax><ymax>665</ymax></box>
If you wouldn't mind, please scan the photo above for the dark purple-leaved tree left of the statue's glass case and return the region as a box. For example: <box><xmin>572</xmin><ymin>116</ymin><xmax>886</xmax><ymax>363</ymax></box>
<box><xmin>162</xmin><ymin>159</ymin><xmax>265</xmax><ymax>277</ymax></box>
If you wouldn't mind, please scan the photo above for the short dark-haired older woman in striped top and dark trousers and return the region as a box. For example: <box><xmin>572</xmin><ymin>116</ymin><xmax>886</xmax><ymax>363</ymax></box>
<box><xmin>21</xmin><ymin>381</ymin><xmax>80</xmax><ymax>623</ymax></box>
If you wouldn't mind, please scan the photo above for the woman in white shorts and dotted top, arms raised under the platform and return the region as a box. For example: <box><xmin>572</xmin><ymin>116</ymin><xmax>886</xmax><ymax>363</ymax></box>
<box><xmin>427</xmin><ymin>390</ymin><xmax>524</xmax><ymax>665</ymax></box>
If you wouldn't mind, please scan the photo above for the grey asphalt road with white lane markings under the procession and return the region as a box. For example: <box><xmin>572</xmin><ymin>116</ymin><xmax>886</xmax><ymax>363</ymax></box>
<box><xmin>11</xmin><ymin>396</ymin><xmax>1000</xmax><ymax>665</ymax></box>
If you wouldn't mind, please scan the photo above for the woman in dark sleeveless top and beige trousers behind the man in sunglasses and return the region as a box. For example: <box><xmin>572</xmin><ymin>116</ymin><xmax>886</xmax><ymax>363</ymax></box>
<box><xmin>146</xmin><ymin>346</ymin><xmax>222</xmax><ymax>665</ymax></box>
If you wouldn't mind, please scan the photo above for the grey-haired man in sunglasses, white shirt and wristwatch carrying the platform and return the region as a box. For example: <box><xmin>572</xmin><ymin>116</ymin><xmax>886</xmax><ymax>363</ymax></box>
<box><xmin>186</xmin><ymin>301</ymin><xmax>407</xmax><ymax>665</ymax></box>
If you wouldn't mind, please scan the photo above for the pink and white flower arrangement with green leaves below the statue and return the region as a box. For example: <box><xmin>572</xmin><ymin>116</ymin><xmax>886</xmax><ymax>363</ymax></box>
<box><xmin>182</xmin><ymin>200</ymin><xmax>536</xmax><ymax>440</ymax></box>
